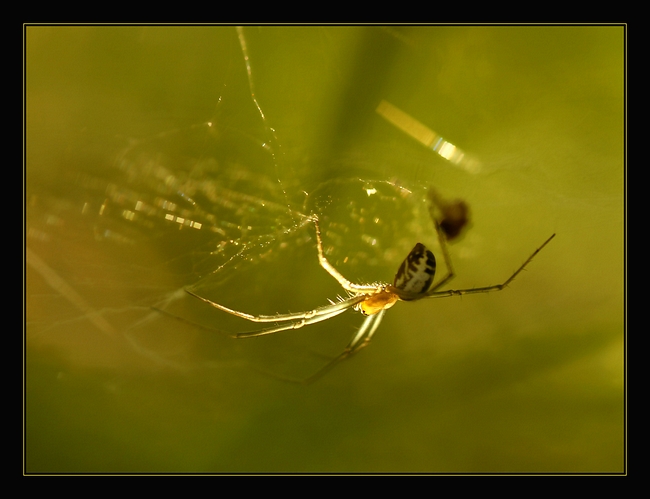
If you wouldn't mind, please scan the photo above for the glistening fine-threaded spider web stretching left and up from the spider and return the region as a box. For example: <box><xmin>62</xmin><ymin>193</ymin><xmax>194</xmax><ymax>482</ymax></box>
<box><xmin>27</xmin><ymin>30</ymin><xmax>460</xmax><ymax>376</ymax></box>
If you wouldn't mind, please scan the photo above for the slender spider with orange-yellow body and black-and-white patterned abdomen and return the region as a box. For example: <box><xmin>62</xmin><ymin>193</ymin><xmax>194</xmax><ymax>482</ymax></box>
<box><xmin>185</xmin><ymin>199</ymin><xmax>555</xmax><ymax>384</ymax></box>
